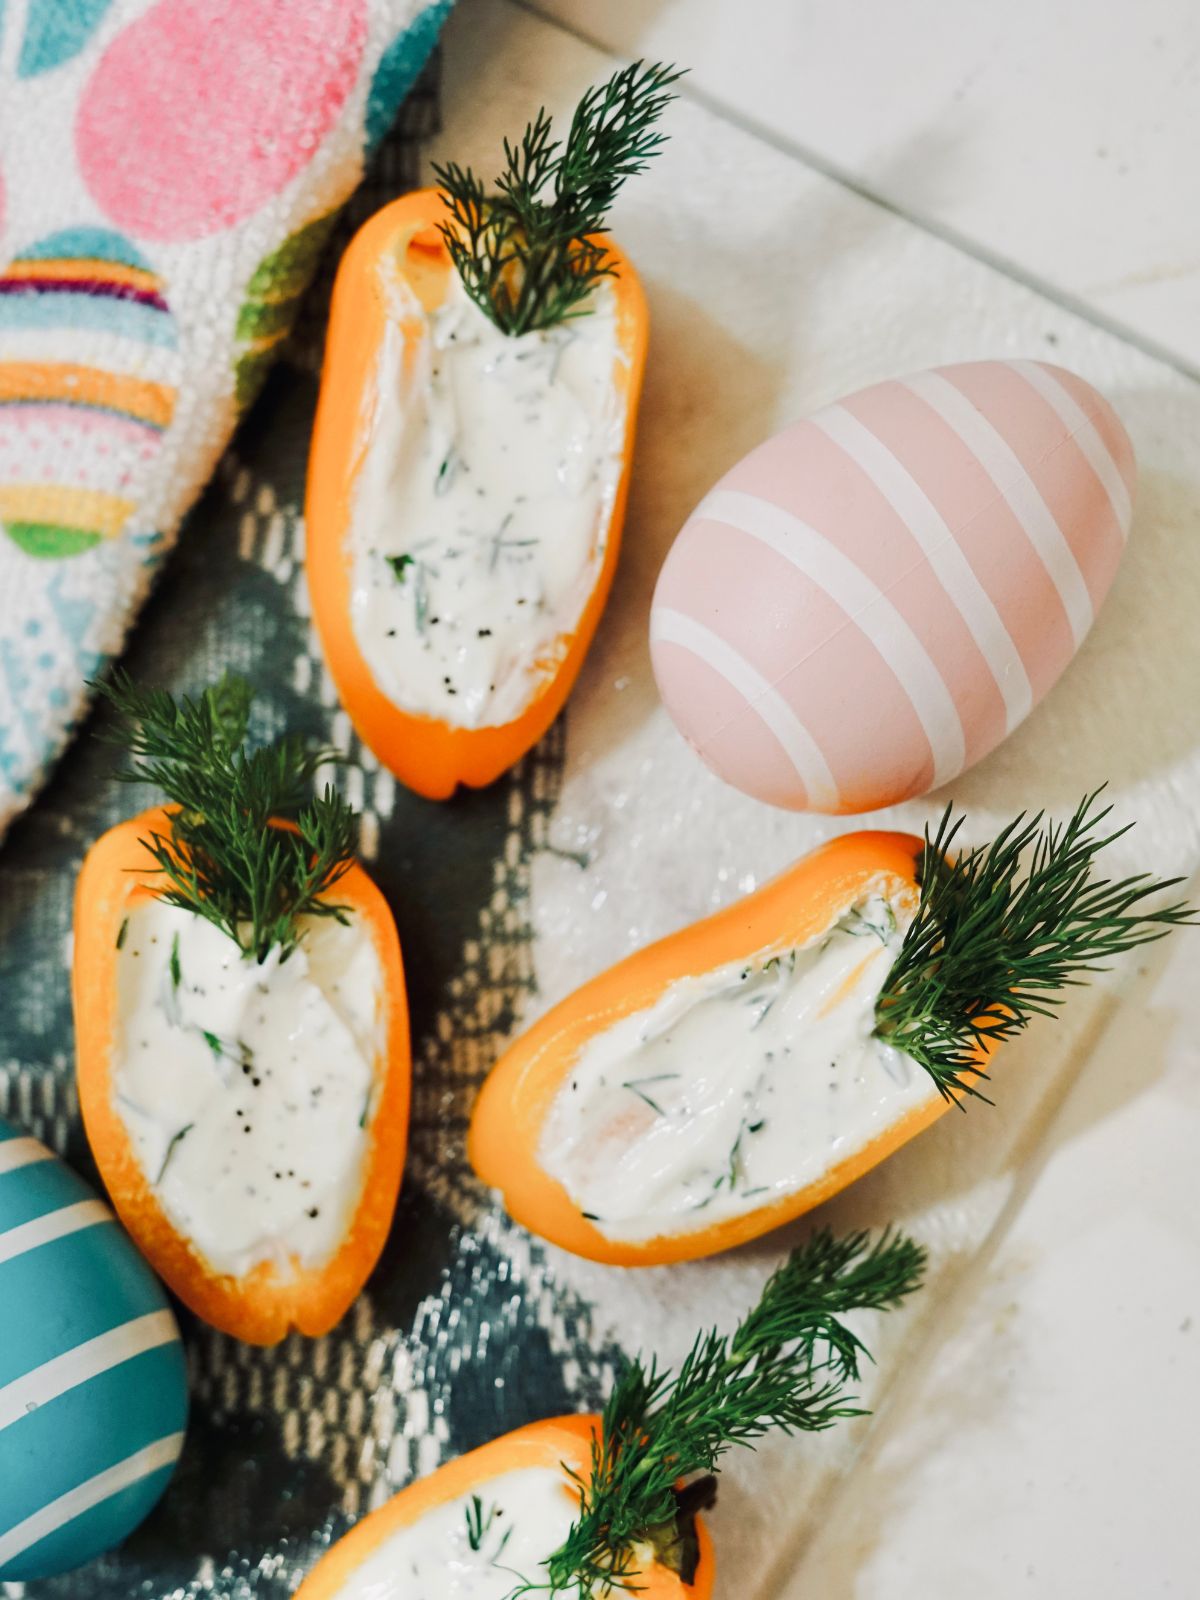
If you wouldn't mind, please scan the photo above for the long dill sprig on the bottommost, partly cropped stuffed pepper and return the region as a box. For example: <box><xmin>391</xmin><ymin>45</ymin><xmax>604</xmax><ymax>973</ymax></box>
<box><xmin>509</xmin><ymin>1232</ymin><xmax>925</xmax><ymax>1600</ymax></box>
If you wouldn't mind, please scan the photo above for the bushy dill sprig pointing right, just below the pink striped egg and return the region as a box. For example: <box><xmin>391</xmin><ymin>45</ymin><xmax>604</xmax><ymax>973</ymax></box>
<box><xmin>875</xmin><ymin>789</ymin><xmax>1197</xmax><ymax>1104</ymax></box>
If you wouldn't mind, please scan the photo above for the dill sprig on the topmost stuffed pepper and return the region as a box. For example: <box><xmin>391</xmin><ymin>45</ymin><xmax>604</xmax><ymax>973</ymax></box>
<box><xmin>434</xmin><ymin>61</ymin><xmax>683</xmax><ymax>334</ymax></box>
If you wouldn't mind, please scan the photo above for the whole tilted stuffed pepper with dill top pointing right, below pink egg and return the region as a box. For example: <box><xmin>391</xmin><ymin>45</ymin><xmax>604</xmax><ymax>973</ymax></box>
<box><xmin>469</xmin><ymin>795</ymin><xmax>1195</xmax><ymax>1266</ymax></box>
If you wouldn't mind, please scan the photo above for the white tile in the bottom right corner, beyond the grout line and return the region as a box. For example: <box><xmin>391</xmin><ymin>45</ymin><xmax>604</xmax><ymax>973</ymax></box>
<box><xmin>784</xmin><ymin>915</ymin><xmax>1200</xmax><ymax>1600</ymax></box>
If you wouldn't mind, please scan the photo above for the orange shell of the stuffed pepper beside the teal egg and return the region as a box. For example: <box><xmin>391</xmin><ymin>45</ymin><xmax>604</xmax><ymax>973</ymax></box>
<box><xmin>72</xmin><ymin>808</ymin><xmax>410</xmax><ymax>1344</ymax></box>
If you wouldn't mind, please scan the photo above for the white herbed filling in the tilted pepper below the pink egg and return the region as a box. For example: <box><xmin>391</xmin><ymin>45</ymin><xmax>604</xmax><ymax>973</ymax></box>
<box><xmin>538</xmin><ymin>894</ymin><xmax>938</xmax><ymax>1242</ymax></box>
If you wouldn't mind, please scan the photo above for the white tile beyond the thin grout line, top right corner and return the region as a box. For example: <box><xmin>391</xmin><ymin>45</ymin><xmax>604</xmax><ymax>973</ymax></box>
<box><xmin>534</xmin><ymin>0</ymin><xmax>1200</xmax><ymax>368</ymax></box>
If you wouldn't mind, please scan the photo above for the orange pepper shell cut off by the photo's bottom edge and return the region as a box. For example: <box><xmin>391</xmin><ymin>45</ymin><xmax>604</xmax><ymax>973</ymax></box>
<box><xmin>296</xmin><ymin>1416</ymin><xmax>715</xmax><ymax>1600</ymax></box>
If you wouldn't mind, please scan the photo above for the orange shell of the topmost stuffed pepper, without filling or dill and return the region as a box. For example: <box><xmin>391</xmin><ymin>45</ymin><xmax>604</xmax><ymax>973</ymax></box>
<box><xmin>306</xmin><ymin>189</ymin><xmax>648</xmax><ymax>800</ymax></box>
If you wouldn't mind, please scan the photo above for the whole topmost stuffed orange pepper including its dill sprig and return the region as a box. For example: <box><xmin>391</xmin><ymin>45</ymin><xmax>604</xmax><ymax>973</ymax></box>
<box><xmin>307</xmin><ymin>62</ymin><xmax>678</xmax><ymax>800</ymax></box>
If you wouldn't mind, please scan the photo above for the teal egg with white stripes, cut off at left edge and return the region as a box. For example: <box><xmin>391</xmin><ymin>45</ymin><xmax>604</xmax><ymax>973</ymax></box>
<box><xmin>0</xmin><ymin>1122</ymin><xmax>187</xmax><ymax>1582</ymax></box>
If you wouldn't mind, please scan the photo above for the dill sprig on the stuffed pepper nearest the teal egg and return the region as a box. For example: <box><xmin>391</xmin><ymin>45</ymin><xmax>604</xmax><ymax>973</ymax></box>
<box><xmin>94</xmin><ymin>670</ymin><xmax>358</xmax><ymax>962</ymax></box>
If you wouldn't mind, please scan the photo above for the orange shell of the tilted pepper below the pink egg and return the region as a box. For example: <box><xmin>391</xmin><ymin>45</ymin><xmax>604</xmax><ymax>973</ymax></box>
<box><xmin>467</xmin><ymin>834</ymin><xmax>982</xmax><ymax>1267</ymax></box>
